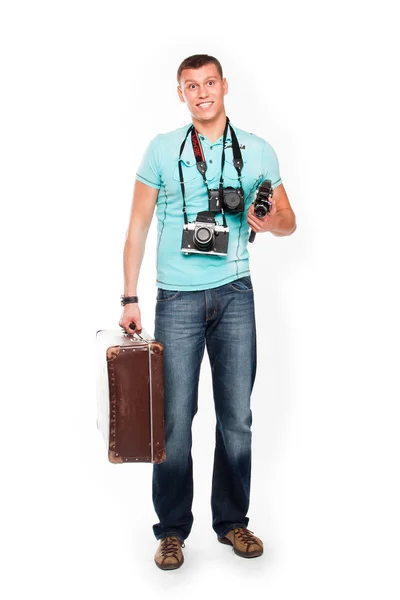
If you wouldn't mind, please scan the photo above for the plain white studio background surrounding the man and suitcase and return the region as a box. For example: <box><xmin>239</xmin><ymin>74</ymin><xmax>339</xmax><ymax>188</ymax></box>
<box><xmin>0</xmin><ymin>0</ymin><xmax>400</xmax><ymax>600</ymax></box>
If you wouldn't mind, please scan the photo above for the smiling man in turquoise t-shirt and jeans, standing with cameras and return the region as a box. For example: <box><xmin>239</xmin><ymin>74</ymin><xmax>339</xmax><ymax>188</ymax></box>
<box><xmin>119</xmin><ymin>55</ymin><xmax>296</xmax><ymax>569</ymax></box>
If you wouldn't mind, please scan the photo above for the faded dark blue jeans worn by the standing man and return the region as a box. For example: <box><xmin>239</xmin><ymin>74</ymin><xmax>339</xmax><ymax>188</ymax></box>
<box><xmin>153</xmin><ymin>276</ymin><xmax>257</xmax><ymax>540</ymax></box>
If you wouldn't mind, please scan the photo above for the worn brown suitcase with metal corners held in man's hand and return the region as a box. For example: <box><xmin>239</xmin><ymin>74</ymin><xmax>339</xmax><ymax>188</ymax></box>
<box><xmin>96</xmin><ymin>329</ymin><xmax>166</xmax><ymax>463</ymax></box>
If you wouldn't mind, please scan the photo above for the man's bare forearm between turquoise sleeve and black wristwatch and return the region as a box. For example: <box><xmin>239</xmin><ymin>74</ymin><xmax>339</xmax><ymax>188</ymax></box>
<box><xmin>124</xmin><ymin>180</ymin><xmax>159</xmax><ymax>296</ymax></box>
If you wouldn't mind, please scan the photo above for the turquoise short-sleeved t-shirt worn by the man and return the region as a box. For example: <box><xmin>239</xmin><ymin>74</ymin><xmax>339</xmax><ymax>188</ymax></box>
<box><xmin>136</xmin><ymin>123</ymin><xmax>282</xmax><ymax>291</ymax></box>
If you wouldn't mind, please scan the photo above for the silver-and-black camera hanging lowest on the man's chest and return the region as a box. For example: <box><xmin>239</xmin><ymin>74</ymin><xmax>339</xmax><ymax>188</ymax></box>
<box><xmin>181</xmin><ymin>211</ymin><xmax>229</xmax><ymax>256</ymax></box>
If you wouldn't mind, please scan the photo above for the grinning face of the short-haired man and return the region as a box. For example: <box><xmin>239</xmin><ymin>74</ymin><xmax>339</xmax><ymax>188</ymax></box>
<box><xmin>178</xmin><ymin>63</ymin><xmax>228</xmax><ymax>121</ymax></box>
